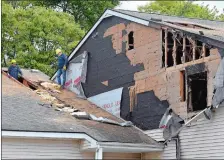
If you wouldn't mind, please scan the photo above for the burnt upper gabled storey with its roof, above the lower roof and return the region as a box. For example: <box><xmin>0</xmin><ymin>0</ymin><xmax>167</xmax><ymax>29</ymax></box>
<box><xmin>52</xmin><ymin>10</ymin><xmax>224</xmax><ymax>158</ymax></box>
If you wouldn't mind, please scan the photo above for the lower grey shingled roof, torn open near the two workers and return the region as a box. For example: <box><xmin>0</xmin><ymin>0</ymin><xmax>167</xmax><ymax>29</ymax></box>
<box><xmin>2</xmin><ymin>74</ymin><xmax>157</xmax><ymax>144</ymax></box>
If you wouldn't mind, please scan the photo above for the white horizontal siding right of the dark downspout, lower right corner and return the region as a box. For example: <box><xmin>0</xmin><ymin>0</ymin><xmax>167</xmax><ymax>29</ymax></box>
<box><xmin>180</xmin><ymin>107</ymin><xmax>224</xmax><ymax>159</ymax></box>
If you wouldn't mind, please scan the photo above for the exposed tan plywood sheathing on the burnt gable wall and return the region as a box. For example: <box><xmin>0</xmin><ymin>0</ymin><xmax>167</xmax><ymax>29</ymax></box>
<box><xmin>104</xmin><ymin>23</ymin><xmax>220</xmax><ymax>118</ymax></box>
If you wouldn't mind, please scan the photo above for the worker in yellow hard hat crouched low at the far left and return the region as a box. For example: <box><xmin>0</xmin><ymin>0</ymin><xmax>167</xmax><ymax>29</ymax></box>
<box><xmin>8</xmin><ymin>59</ymin><xmax>23</xmax><ymax>80</ymax></box>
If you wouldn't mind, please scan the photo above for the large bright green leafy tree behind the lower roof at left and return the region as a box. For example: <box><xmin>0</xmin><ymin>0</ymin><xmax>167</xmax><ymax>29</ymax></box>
<box><xmin>1</xmin><ymin>2</ymin><xmax>84</xmax><ymax>75</ymax></box>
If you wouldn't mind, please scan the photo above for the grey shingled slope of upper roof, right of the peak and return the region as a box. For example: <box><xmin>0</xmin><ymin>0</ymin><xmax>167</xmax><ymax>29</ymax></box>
<box><xmin>113</xmin><ymin>9</ymin><xmax>224</xmax><ymax>29</ymax></box>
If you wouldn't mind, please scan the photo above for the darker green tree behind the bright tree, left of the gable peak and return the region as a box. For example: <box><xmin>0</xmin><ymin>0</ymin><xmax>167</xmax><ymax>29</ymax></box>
<box><xmin>4</xmin><ymin>0</ymin><xmax>119</xmax><ymax>31</ymax></box>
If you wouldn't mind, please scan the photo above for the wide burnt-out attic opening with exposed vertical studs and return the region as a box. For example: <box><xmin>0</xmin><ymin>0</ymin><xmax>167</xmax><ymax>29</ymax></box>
<box><xmin>162</xmin><ymin>29</ymin><xmax>210</xmax><ymax>67</ymax></box>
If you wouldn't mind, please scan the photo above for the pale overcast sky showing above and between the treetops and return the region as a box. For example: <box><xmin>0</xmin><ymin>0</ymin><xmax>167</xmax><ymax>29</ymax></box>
<box><xmin>116</xmin><ymin>1</ymin><xmax>224</xmax><ymax>12</ymax></box>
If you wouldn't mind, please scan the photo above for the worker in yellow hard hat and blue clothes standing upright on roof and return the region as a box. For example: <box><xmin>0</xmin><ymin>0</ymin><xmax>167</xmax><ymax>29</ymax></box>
<box><xmin>56</xmin><ymin>49</ymin><xmax>68</xmax><ymax>88</ymax></box>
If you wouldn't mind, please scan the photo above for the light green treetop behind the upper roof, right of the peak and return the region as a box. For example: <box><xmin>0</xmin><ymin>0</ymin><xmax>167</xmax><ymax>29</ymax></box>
<box><xmin>138</xmin><ymin>0</ymin><xmax>219</xmax><ymax>20</ymax></box>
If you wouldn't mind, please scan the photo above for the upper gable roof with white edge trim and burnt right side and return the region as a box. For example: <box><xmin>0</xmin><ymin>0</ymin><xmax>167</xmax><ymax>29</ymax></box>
<box><xmin>51</xmin><ymin>9</ymin><xmax>224</xmax><ymax>80</ymax></box>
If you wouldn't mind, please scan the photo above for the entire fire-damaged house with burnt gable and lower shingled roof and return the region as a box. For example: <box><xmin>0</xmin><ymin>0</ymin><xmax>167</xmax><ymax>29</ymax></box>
<box><xmin>3</xmin><ymin>10</ymin><xmax>224</xmax><ymax>159</ymax></box>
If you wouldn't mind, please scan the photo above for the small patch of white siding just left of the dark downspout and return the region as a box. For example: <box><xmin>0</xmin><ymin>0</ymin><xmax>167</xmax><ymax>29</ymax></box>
<box><xmin>162</xmin><ymin>140</ymin><xmax>176</xmax><ymax>159</ymax></box>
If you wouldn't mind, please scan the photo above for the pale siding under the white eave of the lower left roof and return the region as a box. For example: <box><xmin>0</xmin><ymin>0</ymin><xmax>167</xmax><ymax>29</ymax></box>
<box><xmin>2</xmin><ymin>138</ymin><xmax>94</xmax><ymax>159</ymax></box>
